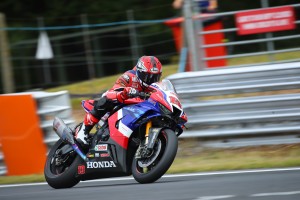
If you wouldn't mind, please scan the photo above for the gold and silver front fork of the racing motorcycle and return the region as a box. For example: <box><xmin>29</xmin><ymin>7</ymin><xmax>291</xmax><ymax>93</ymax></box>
<box><xmin>135</xmin><ymin>121</ymin><xmax>162</xmax><ymax>158</ymax></box>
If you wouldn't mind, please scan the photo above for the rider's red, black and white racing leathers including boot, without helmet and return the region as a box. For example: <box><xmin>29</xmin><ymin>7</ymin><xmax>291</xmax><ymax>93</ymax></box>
<box><xmin>75</xmin><ymin>67</ymin><xmax>156</xmax><ymax>144</ymax></box>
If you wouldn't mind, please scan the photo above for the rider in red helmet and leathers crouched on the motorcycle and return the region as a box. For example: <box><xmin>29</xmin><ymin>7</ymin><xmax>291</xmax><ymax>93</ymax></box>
<box><xmin>75</xmin><ymin>56</ymin><xmax>162</xmax><ymax>145</ymax></box>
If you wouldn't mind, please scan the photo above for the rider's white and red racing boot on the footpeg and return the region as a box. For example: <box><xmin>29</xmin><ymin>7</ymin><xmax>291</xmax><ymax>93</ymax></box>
<box><xmin>75</xmin><ymin>113</ymin><xmax>99</xmax><ymax>146</ymax></box>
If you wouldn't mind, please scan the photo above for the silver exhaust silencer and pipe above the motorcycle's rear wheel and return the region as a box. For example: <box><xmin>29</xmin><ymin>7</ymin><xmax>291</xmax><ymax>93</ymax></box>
<box><xmin>53</xmin><ymin>117</ymin><xmax>88</xmax><ymax>161</ymax></box>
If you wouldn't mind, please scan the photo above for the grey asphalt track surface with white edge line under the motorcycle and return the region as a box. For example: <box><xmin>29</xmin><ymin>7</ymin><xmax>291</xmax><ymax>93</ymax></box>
<box><xmin>0</xmin><ymin>168</ymin><xmax>300</xmax><ymax>200</ymax></box>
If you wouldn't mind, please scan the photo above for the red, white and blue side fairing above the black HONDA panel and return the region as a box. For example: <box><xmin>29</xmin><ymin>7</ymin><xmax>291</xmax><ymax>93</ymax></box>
<box><xmin>108</xmin><ymin>101</ymin><xmax>160</xmax><ymax>149</ymax></box>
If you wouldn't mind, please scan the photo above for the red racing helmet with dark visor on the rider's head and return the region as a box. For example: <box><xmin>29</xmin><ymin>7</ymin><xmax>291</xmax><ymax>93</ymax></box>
<box><xmin>136</xmin><ymin>56</ymin><xmax>162</xmax><ymax>87</ymax></box>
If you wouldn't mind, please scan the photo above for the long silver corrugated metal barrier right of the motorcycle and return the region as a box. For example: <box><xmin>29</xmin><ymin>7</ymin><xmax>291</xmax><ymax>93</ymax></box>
<box><xmin>167</xmin><ymin>62</ymin><xmax>300</xmax><ymax>146</ymax></box>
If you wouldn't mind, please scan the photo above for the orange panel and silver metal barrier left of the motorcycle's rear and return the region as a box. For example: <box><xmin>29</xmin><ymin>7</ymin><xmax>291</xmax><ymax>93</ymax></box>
<box><xmin>0</xmin><ymin>91</ymin><xmax>75</xmax><ymax>175</ymax></box>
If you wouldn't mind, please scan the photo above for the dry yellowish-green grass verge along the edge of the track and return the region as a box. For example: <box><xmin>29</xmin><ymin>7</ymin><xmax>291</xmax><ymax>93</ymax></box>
<box><xmin>0</xmin><ymin>144</ymin><xmax>300</xmax><ymax>184</ymax></box>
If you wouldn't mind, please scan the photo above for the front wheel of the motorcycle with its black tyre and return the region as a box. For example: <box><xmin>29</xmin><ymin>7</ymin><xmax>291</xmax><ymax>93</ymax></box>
<box><xmin>131</xmin><ymin>129</ymin><xmax>178</xmax><ymax>183</ymax></box>
